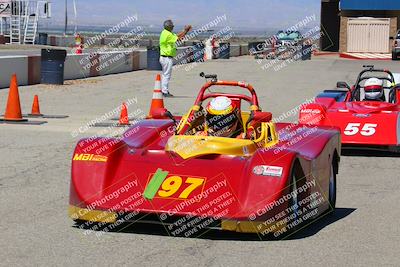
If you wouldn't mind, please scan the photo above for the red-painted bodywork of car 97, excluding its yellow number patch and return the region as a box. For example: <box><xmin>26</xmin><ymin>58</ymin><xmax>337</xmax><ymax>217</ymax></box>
<box><xmin>70</xmin><ymin>120</ymin><xmax>340</xmax><ymax>220</ymax></box>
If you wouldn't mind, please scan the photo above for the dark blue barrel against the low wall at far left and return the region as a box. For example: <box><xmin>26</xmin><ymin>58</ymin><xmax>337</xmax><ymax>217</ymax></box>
<box><xmin>40</xmin><ymin>49</ymin><xmax>67</xmax><ymax>84</ymax></box>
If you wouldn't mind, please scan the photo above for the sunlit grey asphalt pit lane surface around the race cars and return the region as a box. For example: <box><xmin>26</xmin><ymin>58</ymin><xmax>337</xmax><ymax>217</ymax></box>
<box><xmin>0</xmin><ymin>56</ymin><xmax>400</xmax><ymax>266</ymax></box>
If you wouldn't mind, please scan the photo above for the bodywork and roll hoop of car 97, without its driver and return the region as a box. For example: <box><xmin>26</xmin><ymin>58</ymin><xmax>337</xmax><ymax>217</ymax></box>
<box><xmin>70</xmin><ymin>80</ymin><xmax>341</xmax><ymax>232</ymax></box>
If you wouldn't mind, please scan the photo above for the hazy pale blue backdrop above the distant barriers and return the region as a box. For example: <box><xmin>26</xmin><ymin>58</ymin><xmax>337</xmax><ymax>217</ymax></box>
<box><xmin>52</xmin><ymin>0</ymin><xmax>321</xmax><ymax>29</ymax></box>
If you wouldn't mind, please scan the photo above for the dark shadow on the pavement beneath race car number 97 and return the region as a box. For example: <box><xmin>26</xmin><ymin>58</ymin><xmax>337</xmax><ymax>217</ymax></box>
<box><xmin>73</xmin><ymin>208</ymin><xmax>356</xmax><ymax>241</ymax></box>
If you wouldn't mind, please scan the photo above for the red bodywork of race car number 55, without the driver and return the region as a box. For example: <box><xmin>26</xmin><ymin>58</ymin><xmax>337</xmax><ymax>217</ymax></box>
<box><xmin>299</xmin><ymin>91</ymin><xmax>400</xmax><ymax>147</ymax></box>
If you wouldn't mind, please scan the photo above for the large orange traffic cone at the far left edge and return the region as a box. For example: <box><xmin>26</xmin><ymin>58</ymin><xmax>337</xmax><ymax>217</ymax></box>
<box><xmin>4</xmin><ymin>73</ymin><xmax>27</xmax><ymax>122</ymax></box>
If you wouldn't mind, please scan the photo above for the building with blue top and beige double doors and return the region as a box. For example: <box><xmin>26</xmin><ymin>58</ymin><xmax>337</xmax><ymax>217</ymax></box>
<box><xmin>321</xmin><ymin>0</ymin><xmax>400</xmax><ymax>53</ymax></box>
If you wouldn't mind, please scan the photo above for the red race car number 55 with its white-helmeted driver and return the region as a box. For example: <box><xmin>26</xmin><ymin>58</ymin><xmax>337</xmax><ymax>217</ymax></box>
<box><xmin>299</xmin><ymin>65</ymin><xmax>400</xmax><ymax>152</ymax></box>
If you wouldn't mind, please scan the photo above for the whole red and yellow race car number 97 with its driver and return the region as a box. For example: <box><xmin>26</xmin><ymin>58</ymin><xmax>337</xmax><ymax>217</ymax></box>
<box><xmin>69</xmin><ymin>75</ymin><xmax>341</xmax><ymax>239</ymax></box>
